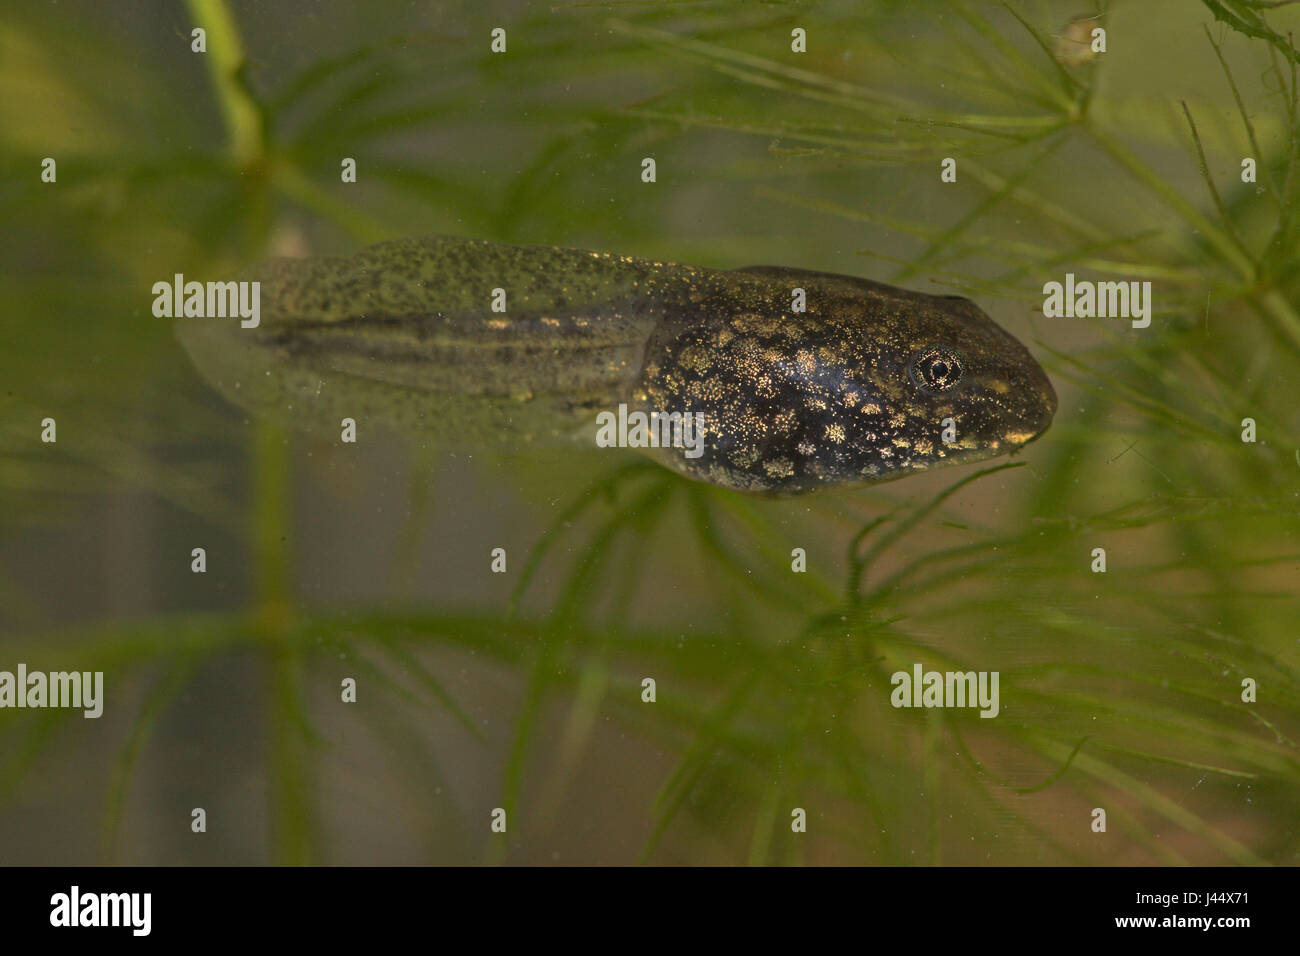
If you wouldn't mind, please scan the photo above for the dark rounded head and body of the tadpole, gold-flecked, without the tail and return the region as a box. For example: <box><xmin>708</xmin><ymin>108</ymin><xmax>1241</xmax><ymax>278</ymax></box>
<box><xmin>638</xmin><ymin>271</ymin><xmax>1057</xmax><ymax>494</ymax></box>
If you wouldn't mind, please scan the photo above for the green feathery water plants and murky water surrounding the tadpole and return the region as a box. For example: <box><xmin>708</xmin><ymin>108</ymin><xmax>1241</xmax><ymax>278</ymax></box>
<box><xmin>0</xmin><ymin>0</ymin><xmax>1300</xmax><ymax>864</ymax></box>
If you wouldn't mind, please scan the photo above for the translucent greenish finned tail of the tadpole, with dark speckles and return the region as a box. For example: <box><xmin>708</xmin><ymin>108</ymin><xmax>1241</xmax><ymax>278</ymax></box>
<box><xmin>177</xmin><ymin>237</ymin><xmax>707</xmax><ymax>440</ymax></box>
